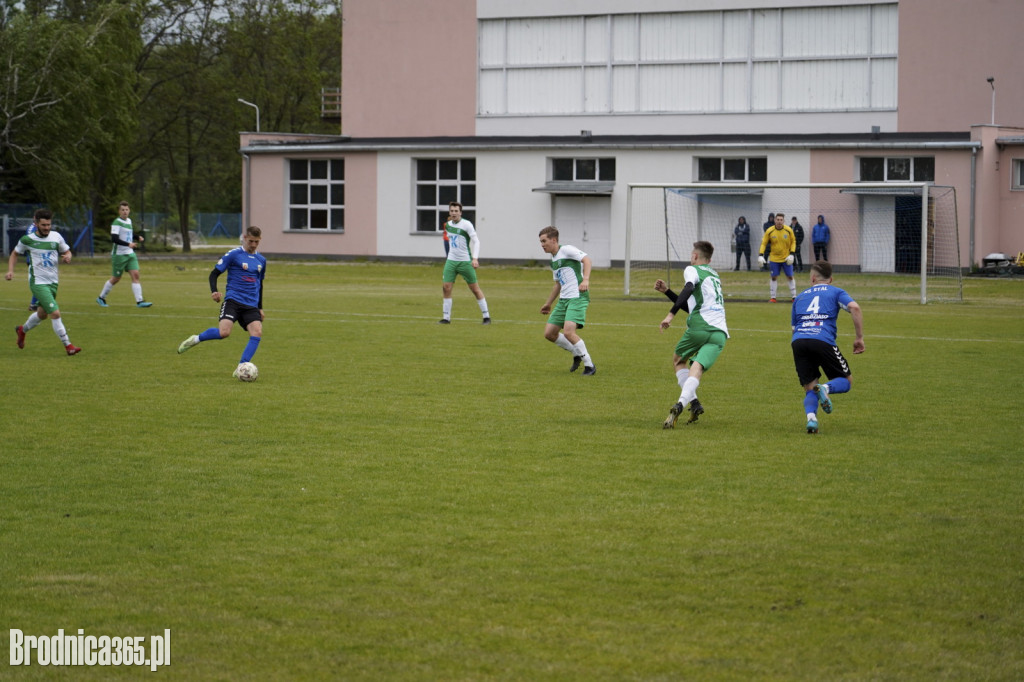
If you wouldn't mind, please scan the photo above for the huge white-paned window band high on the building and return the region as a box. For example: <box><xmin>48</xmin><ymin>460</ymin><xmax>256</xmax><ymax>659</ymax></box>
<box><xmin>477</xmin><ymin>2</ymin><xmax>899</xmax><ymax>116</ymax></box>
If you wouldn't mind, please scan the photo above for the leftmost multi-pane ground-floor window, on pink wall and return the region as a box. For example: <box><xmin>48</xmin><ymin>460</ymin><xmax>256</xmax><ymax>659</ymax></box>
<box><xmin>288</xmin><ymin>159</ymin><xmax>345</xmax><ymax>232</ymax></box>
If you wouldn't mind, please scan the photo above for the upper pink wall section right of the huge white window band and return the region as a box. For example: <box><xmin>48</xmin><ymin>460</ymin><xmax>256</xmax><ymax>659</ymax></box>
<box><xmin>898</xmin><ymin>0</ymin><xmax>1024</xmax><ymax>132</ymax></box>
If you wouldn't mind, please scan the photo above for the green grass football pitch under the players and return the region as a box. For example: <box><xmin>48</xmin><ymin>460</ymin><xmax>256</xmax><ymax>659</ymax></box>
<box><xmin>0</xmin><ymin>255</ymin><xmax>1024</xmax><ymax>680</ymax></box>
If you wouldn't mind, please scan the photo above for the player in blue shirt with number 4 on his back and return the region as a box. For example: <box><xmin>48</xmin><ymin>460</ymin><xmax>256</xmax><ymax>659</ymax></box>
<box><xmin>792</xmin><ymin>260</ymin><xmax>864</xmax><ymax>433</ymax></box>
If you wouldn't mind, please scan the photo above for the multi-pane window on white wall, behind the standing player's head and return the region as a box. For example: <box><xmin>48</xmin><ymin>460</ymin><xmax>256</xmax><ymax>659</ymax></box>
<box><xmin>415</xmin><ymin>159</ymin><xmax>476</xmax><ymax>232</ymax></box>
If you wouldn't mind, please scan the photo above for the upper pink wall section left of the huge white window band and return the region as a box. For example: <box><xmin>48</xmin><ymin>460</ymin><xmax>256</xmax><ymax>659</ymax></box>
<box><xmin>341</xmin><ymin>0</ymin><xmax>476</xmax><ymax>137</ymax></box>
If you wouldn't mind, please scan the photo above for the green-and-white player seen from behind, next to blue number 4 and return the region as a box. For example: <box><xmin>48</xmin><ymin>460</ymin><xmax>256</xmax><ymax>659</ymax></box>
<box><xmin>654</xmin><ymin>242</ymin><xmax>729</xmax><ymax>429</ymax></box>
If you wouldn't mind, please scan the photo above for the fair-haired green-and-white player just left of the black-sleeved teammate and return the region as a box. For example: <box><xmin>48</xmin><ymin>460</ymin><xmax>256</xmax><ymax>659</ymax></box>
<box><xmin>541</xmin><ymin>226</ymin><xmax>597</xmax><ymax>377</ymax></box>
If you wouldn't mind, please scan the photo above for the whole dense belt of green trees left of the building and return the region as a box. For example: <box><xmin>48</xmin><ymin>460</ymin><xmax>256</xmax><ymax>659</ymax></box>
<box><xmin>0</xmin><ymin>0</ymin><xmax>341</xmax><ymax>250</ymax></box>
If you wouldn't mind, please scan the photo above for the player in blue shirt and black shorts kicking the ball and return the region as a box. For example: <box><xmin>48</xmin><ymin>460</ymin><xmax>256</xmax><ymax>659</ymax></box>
<box><xmin>178</xmin><ymin>225</ymin><xmax>266</xmax><ymax>377</ymax></box>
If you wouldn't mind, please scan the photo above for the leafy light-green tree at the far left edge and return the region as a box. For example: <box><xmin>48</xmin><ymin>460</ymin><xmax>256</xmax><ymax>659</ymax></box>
<box><xmin>0</xmin><ymin>2</ymin><xmax>138</xmax><ymax>208</ymax></box>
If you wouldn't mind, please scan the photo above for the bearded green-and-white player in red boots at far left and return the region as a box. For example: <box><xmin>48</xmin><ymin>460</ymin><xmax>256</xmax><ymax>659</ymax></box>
<box><xmin>5</xmin><ymin>209</ymin><xmax>82</xmax><ymax>355</ymax></box>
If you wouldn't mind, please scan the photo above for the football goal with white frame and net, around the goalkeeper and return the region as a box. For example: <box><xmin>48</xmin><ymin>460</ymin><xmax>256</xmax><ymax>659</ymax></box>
<box><xmin>625</xmin><ymin>182</ymin><xmax>963</xmax><ymax>303</ymax></box>
